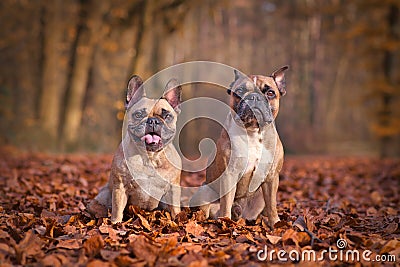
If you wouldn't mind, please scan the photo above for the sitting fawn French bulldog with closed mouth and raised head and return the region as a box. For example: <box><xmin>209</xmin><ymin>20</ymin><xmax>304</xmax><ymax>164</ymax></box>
<box><xmin>191</xmin><ymin>66</ymin><xmax>288</xmax><ymax>227</ymax></box>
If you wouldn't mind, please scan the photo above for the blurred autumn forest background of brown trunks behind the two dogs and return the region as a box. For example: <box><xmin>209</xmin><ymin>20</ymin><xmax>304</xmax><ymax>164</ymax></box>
<box><xmin>0</xmin><ymin>0</ymin><xmax>400</xmax><ymax>156</ymax></box>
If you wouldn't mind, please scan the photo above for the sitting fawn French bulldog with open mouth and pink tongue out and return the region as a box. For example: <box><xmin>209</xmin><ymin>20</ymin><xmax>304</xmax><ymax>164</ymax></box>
<box><xmin>88</xmin><ymin>75</ymin><xmax>182</xmax><ymax>223</ymax></box>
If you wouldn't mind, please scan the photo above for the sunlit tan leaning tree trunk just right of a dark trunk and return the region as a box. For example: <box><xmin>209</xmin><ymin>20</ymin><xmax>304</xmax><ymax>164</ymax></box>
<box><xmin>62</xmin><ymin>0</ymin><xmax>108</xmax><ymax>149</ymax></box>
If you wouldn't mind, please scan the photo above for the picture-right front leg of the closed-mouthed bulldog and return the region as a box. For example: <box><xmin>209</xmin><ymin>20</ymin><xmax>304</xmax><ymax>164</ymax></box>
<box><xmin>261</xmin><ymin>173</ymin><xmax>279</xmax><ymax>228</ymax></box>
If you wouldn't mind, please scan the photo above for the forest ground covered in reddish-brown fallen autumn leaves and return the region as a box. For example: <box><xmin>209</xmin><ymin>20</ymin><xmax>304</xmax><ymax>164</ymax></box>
<box><xmin>0</xmin><ymin>151</ymin><xmax>400</xmax><ymax>267</ymax></box>
